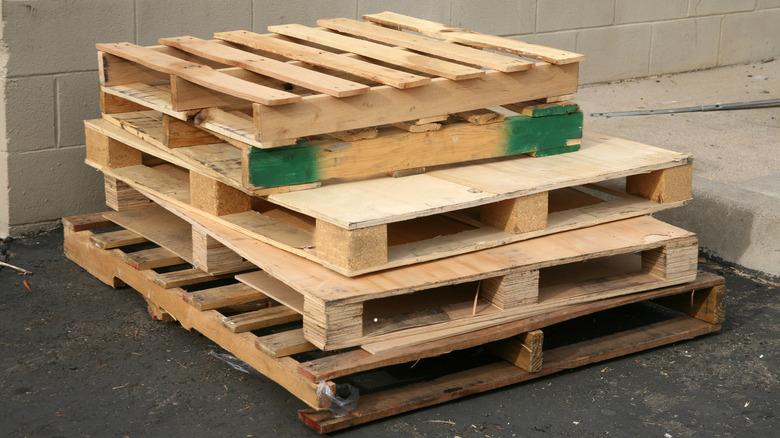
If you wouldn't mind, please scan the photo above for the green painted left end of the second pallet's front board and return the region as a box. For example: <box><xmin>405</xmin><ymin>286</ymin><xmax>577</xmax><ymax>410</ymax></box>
<box><xmin>249</xmin><ymin>140</ymin><xmax>319</xmax><ymax>187</ymax></box>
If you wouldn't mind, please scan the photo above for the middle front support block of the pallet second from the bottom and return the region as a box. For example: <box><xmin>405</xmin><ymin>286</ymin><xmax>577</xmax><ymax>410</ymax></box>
<box><xmin>479</xmin><ymin>270</ymin><xmax>539</xmax><ymax>309</ymax></box>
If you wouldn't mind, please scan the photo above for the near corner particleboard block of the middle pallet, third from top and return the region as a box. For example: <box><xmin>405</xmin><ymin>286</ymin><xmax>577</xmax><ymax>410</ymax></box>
<box><xmin>314</xmin><ymin>219</ymin><xmax>387</xmax><ymax>270</ymax></box>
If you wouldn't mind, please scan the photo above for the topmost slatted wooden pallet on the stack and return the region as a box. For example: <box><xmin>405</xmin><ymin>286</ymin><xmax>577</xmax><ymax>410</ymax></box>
<box><xmin>97</xmin><ymin>12</ymin><xmax>583</xmax><ymax>148</ymax></box>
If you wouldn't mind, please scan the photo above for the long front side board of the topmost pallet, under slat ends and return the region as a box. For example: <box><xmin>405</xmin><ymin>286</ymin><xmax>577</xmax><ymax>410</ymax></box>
<box><xmin>254</xmin><ymin>62</ymin><xmax>579</xmax><ymax>141</ymax></box>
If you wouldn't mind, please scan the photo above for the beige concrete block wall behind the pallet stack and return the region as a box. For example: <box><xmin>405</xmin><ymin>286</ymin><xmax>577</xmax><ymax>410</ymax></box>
<box><xmin>0</xmin><ymin>0</ymin><xmax>780</xmax><ymax>237</ymax></box>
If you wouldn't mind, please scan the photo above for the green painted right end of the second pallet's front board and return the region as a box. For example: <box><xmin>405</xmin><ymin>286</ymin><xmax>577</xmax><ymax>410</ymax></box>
<box><xmin>504</xmin><ymin>111</ymin><xmax>583</xmax><ymax>156</ymax></box>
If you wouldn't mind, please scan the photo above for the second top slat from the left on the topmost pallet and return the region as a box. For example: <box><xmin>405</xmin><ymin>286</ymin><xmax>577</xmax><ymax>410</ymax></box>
<box><xmin>160</xmin><ymin>36</ymin><xmax>369</xmax><ymax>97</ymax></box>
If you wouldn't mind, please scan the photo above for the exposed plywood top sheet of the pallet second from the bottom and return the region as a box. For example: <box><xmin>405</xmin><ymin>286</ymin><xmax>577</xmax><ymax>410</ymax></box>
<box><xmin>128</xmin><ymin>186</ymin><xmax>695</xmax><ymax>308</ymax></box>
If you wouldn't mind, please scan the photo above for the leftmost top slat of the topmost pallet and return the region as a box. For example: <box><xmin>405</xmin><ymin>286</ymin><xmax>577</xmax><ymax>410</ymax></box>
<box><xmin>97</xmin><ymin>43</ymin><xmax>301</xmax><ymax>105</ymax></box>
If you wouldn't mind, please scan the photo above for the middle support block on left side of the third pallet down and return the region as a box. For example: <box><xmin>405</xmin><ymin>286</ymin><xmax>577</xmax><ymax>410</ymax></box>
<box><xmin>190</xmin><ymin>172</ymin><xmax>252</xmax><ymax>216</ymax></box>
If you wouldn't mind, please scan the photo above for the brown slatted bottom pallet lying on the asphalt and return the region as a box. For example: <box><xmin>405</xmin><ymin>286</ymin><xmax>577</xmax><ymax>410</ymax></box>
<box><xmin>63</xmin><ymin>215</ymin><xmax>725</xmax><ymax>433</ymax></box>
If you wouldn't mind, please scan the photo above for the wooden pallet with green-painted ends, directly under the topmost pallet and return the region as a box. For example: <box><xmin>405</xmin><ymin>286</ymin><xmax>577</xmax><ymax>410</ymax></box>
<box><xmin>86</xmin><ymin>103</ymin><xmax>582</xmax><ymax>195</ymax></box>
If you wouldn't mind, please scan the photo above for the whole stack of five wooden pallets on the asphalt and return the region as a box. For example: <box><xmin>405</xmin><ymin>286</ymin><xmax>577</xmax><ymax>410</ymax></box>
<box><xmin>64</xmin><ymin>12</ymin><xmax>725</xmax><ymax>432</ymax></box>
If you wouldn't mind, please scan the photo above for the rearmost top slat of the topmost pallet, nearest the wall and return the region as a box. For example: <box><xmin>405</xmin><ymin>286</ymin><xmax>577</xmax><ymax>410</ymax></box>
<box><xmin>363</xmin><ymin>12</ymin><xmax>584</xmax><ymax>65</ymax></box>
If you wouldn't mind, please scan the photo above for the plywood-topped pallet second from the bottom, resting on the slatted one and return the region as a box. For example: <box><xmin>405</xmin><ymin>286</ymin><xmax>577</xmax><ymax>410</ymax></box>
<box><xmin>79</xmin><ymin>174</ymin><xmax>698</xmax><ymax>352</ymax></box>
